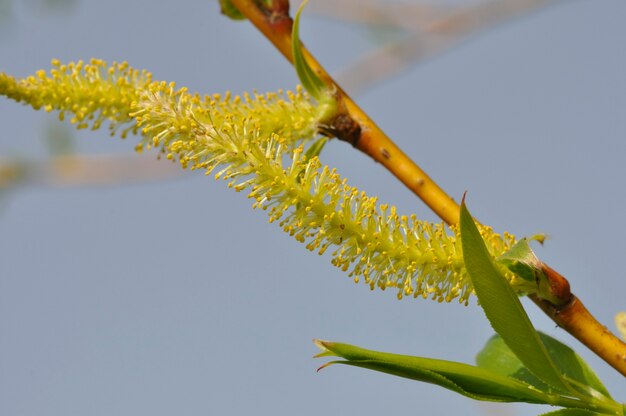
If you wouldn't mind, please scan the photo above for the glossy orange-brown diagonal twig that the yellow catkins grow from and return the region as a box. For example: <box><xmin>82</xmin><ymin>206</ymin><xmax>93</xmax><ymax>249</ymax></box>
<box><xmin>231</xmin><ymin>0</ymin><xmax>626</xmax><ymax>376</ymax></box>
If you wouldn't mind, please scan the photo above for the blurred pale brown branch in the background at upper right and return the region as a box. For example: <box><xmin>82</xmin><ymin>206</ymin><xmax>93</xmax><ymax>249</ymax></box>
<box><xmin>311</xmin><ymin>0</ymin><xmax>558</xmax><ymax>94</ymax></box>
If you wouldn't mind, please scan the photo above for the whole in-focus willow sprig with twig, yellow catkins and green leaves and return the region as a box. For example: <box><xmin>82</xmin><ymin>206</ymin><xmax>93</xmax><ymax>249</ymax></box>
<box><xmin>0</xmin><ymin>0</ymin><xmax>625</xmax><ymax>415</ymax></box>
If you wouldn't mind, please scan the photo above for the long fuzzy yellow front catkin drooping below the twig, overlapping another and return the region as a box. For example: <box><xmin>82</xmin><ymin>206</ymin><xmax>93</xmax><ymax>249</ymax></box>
<box><xmin>134</xmin><ymin>80</ymin><xmax>514</xmax><ymax>303</ymax></box>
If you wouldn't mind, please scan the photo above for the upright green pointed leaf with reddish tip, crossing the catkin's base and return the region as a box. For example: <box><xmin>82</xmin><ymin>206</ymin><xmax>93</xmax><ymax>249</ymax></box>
<box><xmin>460</xmin><ymin>203</ymin><xmax>575</xmax><ymax>394</ymax></box>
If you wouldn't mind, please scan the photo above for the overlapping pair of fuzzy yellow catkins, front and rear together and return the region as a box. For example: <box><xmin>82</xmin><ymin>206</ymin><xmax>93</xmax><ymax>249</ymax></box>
<box><xmin>0</xmin><ymin>61</ymin><xmax>515</xmax><ymax>304</ymax></box>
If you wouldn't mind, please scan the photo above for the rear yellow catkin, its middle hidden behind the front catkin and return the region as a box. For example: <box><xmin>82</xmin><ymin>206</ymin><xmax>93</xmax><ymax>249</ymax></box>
<box><xmin>0</xmin><ymin>59</ymin><xmax>321</xmax><ymax>148</ymax></box>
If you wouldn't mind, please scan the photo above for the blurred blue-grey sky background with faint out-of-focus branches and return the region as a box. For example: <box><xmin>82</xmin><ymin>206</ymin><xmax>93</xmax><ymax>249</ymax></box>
<box><xmin>0</xmin><ymin>0</ymin><xmax>626</xmax><ymax>416</ymax></box>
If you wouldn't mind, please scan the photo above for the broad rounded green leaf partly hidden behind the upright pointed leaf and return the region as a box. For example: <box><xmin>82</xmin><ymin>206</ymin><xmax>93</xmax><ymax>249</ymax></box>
<box><xmin>476</xmin><ymin>332</ymin><xmax>611</xmax><ymax>400</ymax></box>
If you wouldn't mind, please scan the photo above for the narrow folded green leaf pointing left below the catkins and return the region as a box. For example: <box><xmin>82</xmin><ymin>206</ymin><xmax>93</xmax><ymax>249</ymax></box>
<box><xmin>316</xmin><ymin>340</ymin><xmax>555</xmax><ymax>404</ymax></box>
